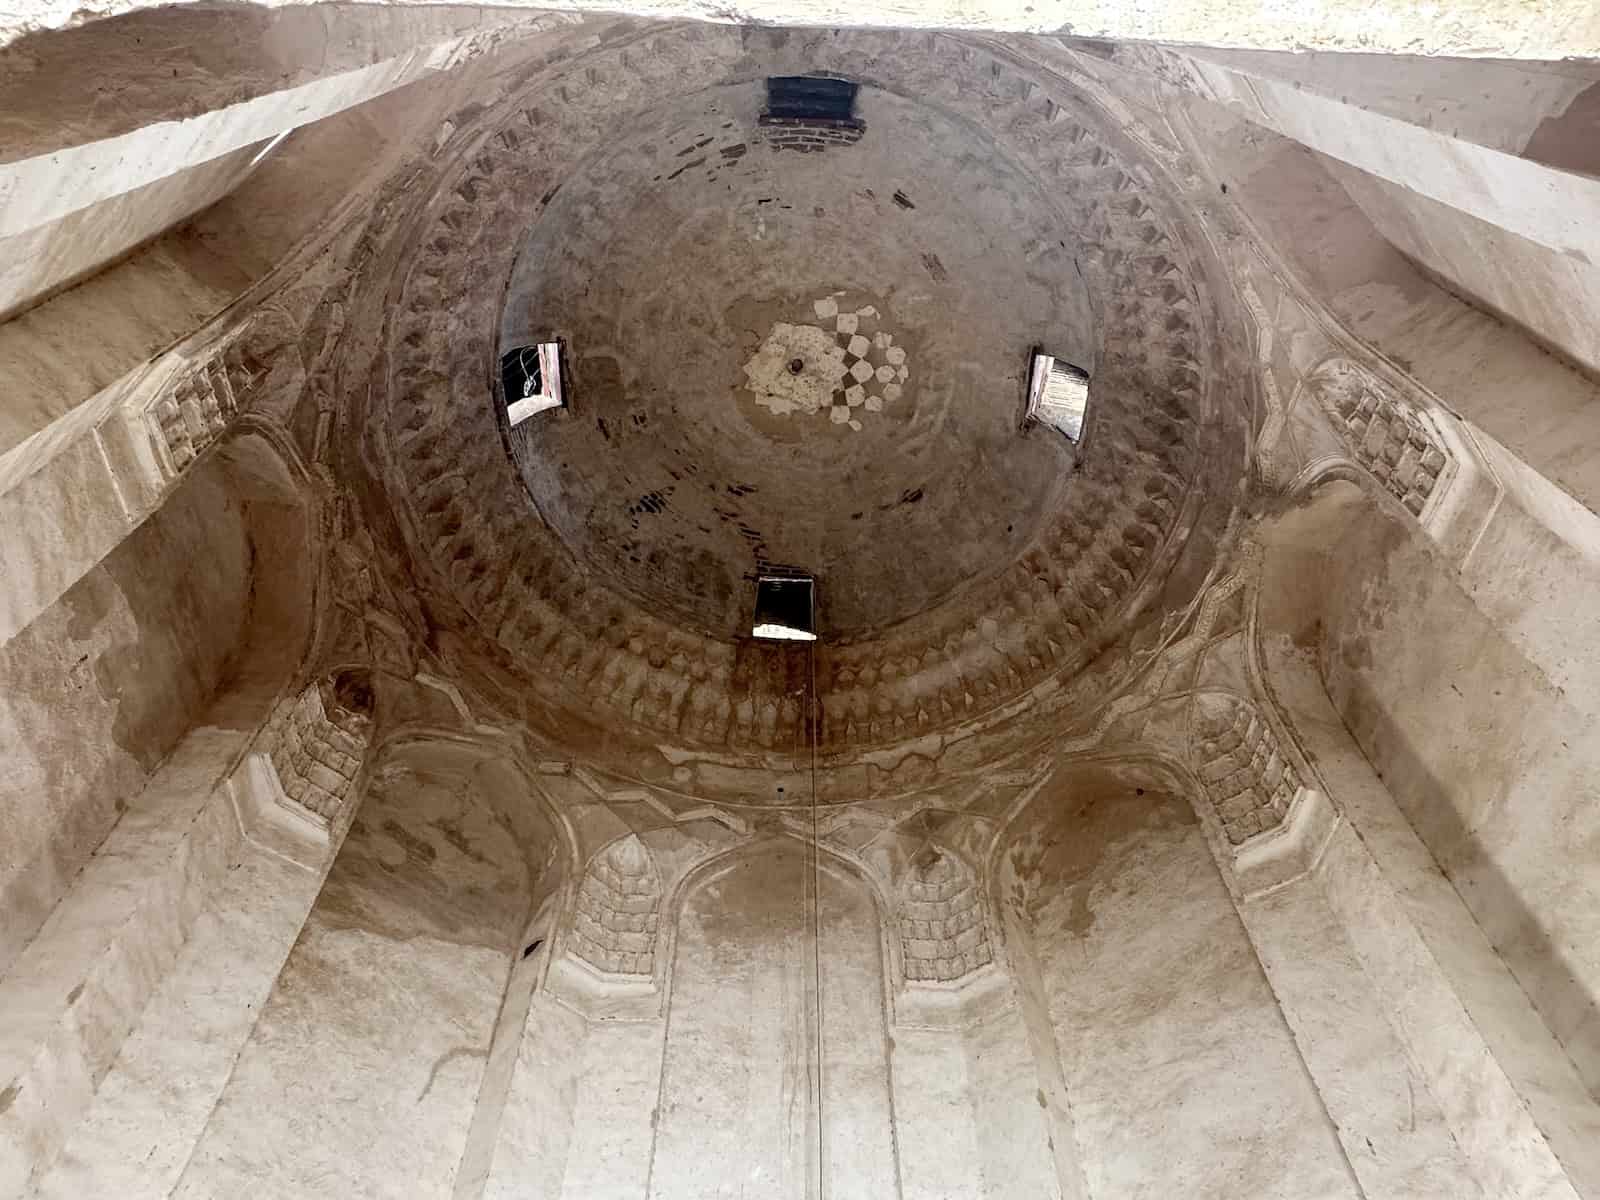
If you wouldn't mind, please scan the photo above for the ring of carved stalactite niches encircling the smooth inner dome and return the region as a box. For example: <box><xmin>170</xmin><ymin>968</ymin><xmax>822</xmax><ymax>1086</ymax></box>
<box><xmin>371</xmin><ymin>29</ymin><xmax>1208</xmax><ymax>749</ymax></box>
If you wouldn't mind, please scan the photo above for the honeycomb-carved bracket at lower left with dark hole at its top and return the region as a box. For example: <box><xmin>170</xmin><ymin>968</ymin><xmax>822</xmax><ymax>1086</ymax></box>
<box><xmin>264</xmin><ymin>683</ymin><xmax>371</xmax><ymax>824</ymax></box>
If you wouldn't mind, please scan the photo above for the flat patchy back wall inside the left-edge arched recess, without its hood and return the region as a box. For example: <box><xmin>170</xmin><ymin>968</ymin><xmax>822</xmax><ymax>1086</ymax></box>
<box><xmin>0</xmin><ymin>457</ymin><xmax>253</xmax><ymax>970</ymax></box>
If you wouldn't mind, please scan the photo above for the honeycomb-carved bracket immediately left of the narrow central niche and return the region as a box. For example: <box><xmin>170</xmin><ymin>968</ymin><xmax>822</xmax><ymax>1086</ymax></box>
<box><xmin>573</xmin><ymin>835</ymin><xmax>661</xmax><ymax>976</ymax></box>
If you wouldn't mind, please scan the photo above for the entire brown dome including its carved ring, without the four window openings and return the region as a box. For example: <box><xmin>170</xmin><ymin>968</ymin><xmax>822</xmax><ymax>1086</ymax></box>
<box><xmin>358</xmin><ymin>26</ymin><xmax>1248</xmax><ymax>757</ymax></box>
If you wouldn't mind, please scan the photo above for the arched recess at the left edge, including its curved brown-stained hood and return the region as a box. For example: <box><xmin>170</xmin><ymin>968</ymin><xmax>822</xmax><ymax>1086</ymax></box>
<box><xmin>0</xmin><ymin>422</ymin><xmax>312</xmax><ymax>973</ymax></box>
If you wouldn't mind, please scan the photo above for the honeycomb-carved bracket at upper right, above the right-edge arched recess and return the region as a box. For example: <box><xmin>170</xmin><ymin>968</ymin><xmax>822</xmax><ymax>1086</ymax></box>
<box><xmin>1306</xmin><ymin>358</ymin><xmax>1451</xmax><ymax>517</ymax></box>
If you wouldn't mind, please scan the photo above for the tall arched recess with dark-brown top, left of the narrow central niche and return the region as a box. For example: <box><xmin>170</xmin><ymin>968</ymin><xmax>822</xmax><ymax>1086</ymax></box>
<box><xmin>174</xmin><ymin>742</ymin><xmax>544</xmax><ymax>1200</ymax></box>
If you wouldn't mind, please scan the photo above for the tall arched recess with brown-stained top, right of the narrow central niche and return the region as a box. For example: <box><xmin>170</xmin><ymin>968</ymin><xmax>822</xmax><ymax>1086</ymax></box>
<box><xmin>989</xmin><ymin>757</ymin><xmax>1360</xmax><ymax>1197</ymax></box>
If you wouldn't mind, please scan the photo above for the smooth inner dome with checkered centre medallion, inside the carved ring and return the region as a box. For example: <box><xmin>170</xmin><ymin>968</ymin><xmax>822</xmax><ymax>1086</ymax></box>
<box><xmin>501</xmin><ymin>83</ymin><xmax>1094</xmax><ymax>637</ymax></box>
